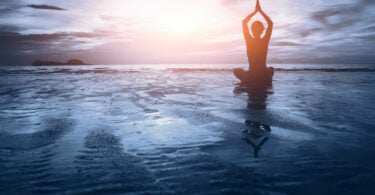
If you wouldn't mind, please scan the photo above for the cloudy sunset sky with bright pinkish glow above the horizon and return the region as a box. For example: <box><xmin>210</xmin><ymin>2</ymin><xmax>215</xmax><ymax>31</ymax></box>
<box><xmin>0</xmin><ymin>0</ymin><xmax>375</xmax><ymax>65</ymax></box>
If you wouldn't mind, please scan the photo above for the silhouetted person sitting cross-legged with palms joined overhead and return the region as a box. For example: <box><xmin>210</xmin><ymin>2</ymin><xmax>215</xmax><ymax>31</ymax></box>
<box><xmin>234</xmin><ymin>0</ymin><xmax>274</xmax><ymax>83</ymax></box>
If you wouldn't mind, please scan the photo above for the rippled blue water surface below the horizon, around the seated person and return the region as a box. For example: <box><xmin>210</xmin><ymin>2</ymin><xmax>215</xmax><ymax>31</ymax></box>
<box><xmin>0</xmin><ymin>64</ymin><xmax>375</xmax><ymax>194</ymax></box>
